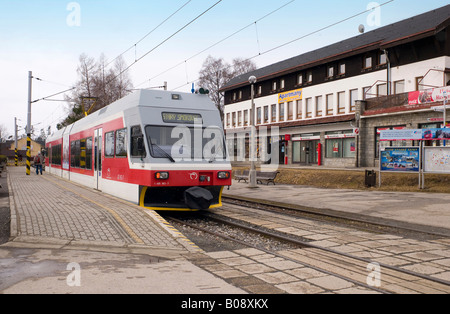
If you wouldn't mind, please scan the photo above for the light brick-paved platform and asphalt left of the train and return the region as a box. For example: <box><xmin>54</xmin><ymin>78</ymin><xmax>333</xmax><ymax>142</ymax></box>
<box><xmin>0</xmin><ymin>167</ymin><xmax>243</xmax><ymax>294</ymax></box>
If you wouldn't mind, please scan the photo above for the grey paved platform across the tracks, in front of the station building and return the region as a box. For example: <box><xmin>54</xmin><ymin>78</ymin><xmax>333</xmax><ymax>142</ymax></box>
<box><xmin>223</xmin><ymin>181</ymin><xmax>450</xmax><ymax>237</ymax></box>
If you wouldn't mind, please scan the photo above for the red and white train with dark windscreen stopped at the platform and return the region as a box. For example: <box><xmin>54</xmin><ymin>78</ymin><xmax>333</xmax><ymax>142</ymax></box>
<box><xmin>46</xmin><ymin>90</ymin><xmax>231</xmax><ymax>211</ymax></box>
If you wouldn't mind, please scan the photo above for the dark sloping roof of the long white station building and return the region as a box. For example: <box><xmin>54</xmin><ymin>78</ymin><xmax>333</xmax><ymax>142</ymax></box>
<box><xmin>221</xmin><ymin>5</ymin><xmax>450</xmax><ymax>91</ymax></box>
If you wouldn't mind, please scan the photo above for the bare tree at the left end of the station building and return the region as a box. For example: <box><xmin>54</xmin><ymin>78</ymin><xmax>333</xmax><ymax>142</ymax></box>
<box><xmin>199</xmin><ymin>56</ymin><xmax>256</xmax><ymax>121</ymax></box>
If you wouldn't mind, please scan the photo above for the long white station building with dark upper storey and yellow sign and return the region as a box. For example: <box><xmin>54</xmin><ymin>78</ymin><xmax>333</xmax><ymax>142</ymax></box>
<box><xmin>222</xmin><ymin>5</ymin><xmax>450</xmax><ymax>168</ymax></box>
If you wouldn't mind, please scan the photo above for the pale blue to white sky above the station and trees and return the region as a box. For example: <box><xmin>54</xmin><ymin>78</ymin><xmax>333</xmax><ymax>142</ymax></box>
<box><xmin>0</xmin><ymin>0</ymin><xmax>448</xmax><ymax>135</ymax></box>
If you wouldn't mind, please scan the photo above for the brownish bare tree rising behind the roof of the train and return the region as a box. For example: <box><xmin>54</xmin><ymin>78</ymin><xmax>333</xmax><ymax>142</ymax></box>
<box><xmin>58</xmin><ymin>54</ymin><xmax>133</xmax><ymax>129</ymax></box>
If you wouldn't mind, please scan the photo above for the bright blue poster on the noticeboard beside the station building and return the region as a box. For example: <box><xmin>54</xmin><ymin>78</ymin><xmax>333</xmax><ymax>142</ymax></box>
<box><xmin>380</xmin><ymin>147</ymin><xmax>420</xmax><ymax>172</ymax></box>
